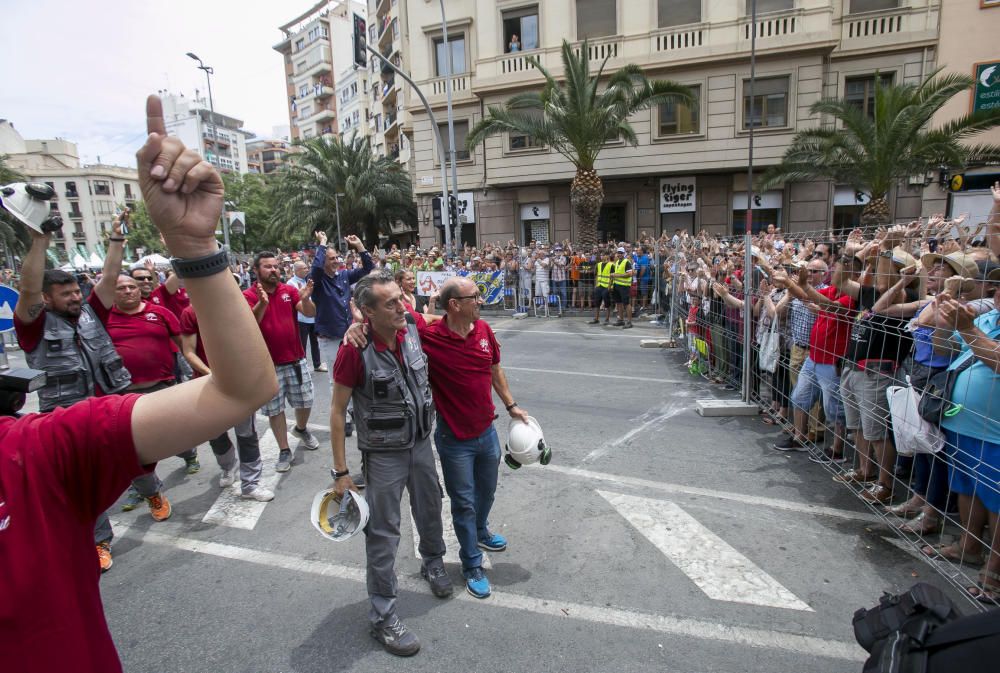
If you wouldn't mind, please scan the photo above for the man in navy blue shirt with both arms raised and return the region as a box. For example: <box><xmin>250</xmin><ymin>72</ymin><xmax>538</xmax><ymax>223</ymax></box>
<box><xmin>310</xmin><ymin>231</ymin><xmax>375</xmax><ymax>437</ymax></box>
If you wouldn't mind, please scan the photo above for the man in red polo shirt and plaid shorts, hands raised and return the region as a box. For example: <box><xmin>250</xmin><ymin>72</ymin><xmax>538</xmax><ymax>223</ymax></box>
<box><xmin>243</xmin><ymin>252</ymin><xmax>319</xmax><ymax>472</ymax></box>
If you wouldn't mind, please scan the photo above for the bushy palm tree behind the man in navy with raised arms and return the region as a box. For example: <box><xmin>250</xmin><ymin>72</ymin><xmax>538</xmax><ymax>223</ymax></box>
<box><xmin>272</xmin><ymin>134</ymin><xmax>416</xmax><ymax>243</ymax></box>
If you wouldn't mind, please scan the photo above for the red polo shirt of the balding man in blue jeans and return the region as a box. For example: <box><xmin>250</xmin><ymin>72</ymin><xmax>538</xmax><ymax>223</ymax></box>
<box><xmin>416</xmin><ymin>314</ymin><xmax>500</xmax><ymax>440</ymax></box>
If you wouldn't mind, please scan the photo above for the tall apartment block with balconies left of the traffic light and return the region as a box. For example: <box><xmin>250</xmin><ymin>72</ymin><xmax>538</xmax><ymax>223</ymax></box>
<box><xmin>274</xmin><ymin>0</ymin><xmax>366</xmax><ymax>141</ymax></box>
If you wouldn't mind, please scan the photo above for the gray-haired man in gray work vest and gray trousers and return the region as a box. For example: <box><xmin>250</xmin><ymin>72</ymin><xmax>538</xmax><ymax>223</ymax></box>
<box><xmin>330</xmin><ymin>269</ymin><xmax>452</xmax><ymax>656</ymax></box>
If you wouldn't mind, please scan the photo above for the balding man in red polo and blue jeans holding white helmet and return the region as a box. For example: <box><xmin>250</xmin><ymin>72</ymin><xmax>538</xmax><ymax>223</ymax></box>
<box><xmin>344</xmin><ymin>277</ymin><xmax>528</xmax><ymax>598</ymax></box>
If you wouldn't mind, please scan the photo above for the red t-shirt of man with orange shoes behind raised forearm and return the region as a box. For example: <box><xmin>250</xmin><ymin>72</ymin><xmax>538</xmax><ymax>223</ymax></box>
<box><xmin>87</xmin><ymin>292</ymin><xmax>181</xmax><ymax>384</ymax></box>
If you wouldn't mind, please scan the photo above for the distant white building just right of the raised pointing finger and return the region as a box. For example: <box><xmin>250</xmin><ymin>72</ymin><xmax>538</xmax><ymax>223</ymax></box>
<box><xmin>159</xmin><ymin>91</ymin><xmax>253</xmax><ymax>173</ymax></box>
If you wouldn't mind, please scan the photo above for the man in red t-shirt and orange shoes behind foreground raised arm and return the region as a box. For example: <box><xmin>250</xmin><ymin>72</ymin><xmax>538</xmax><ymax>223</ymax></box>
<box><xmin>87</xmin><ymin>269</ymin><xmax>200</xmax><ymax>521</ymax></box>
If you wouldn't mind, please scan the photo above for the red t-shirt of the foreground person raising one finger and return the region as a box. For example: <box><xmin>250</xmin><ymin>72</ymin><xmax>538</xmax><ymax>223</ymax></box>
<box><xmin>0</xmin><ymin>395</ymin><xmax>143</xmax><ymax>673</ymax></box>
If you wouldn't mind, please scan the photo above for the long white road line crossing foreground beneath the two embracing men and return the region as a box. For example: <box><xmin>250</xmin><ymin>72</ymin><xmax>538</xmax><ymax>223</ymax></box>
<box><xmin>123</xmin><ymin>522</ymin><xmax>868</xmax><ymax>662</ymax></box>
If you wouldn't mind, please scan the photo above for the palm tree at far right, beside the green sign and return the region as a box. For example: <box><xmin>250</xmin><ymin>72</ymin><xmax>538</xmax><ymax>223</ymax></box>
<box><xmin>757</xmin><ymin>70</ymin><xmax>1000</xmax><ymax>226</ymax></box>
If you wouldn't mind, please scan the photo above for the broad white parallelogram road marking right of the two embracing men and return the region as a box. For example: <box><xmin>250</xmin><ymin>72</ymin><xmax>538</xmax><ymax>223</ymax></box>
<box><xmin>597</xmin><ymin>491</ymin><xmax>813</xmax><ymax>612</ymax></box>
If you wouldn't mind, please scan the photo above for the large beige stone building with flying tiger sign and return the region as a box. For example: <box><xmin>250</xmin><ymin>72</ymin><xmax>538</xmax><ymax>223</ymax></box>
<box><xmin>402</xmin><ymin>0</ymin><xmax>940</xmax><ymax>243</ymax></box>
